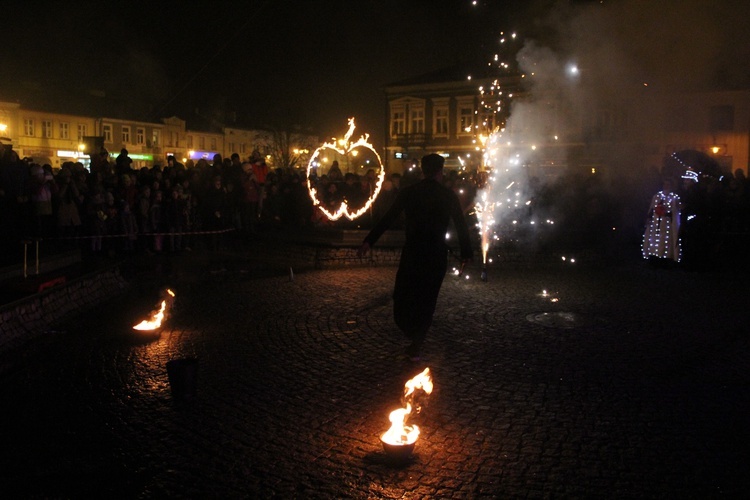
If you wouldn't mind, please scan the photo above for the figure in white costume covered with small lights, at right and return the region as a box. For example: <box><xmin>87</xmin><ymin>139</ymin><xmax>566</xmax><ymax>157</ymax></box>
<box><xmin>643</xmin><ymin>181</ymin><xmax>682</xmax><ymax>262</ymax></box>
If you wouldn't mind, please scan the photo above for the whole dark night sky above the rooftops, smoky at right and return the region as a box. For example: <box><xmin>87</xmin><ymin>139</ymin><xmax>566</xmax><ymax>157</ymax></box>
<box><xmin>0</xmin><ymin>0</ymin><xmax>750</xmax><ymax>146</ymax></box>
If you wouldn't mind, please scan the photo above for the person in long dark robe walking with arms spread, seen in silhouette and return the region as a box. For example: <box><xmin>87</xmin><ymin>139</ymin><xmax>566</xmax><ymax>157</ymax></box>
<box><xmin>357</xmin><ymin>154</ymin><xmax>472</xmax><ymax>361</ymax></box>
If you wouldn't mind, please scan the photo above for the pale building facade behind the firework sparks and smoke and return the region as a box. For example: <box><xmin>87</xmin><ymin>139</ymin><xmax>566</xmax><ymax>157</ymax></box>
<box><xmin>385</xmin><ymin>69</ymin><xmax>750</xmax><ymax>179</ymax></box>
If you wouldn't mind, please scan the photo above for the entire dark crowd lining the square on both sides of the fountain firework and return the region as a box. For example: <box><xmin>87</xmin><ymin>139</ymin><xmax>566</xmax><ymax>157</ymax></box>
<box><xmin>0</xmin><ymin>142</ymin><xmax>750</xmax><ymax>270</ymax></box>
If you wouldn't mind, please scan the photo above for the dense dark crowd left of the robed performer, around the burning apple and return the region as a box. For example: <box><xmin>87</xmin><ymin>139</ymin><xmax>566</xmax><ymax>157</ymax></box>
<box><xmin>0</xmin><ymin>148</ymin><xmax>412</xmax><ymax>263</ymax></box>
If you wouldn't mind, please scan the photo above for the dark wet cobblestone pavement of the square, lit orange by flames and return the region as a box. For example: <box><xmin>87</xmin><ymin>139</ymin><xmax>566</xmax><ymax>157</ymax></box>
<box><xmin>0</xmin><ymin>252</ymin><xmax>750</xmax><ymax>498</ymax></box>
